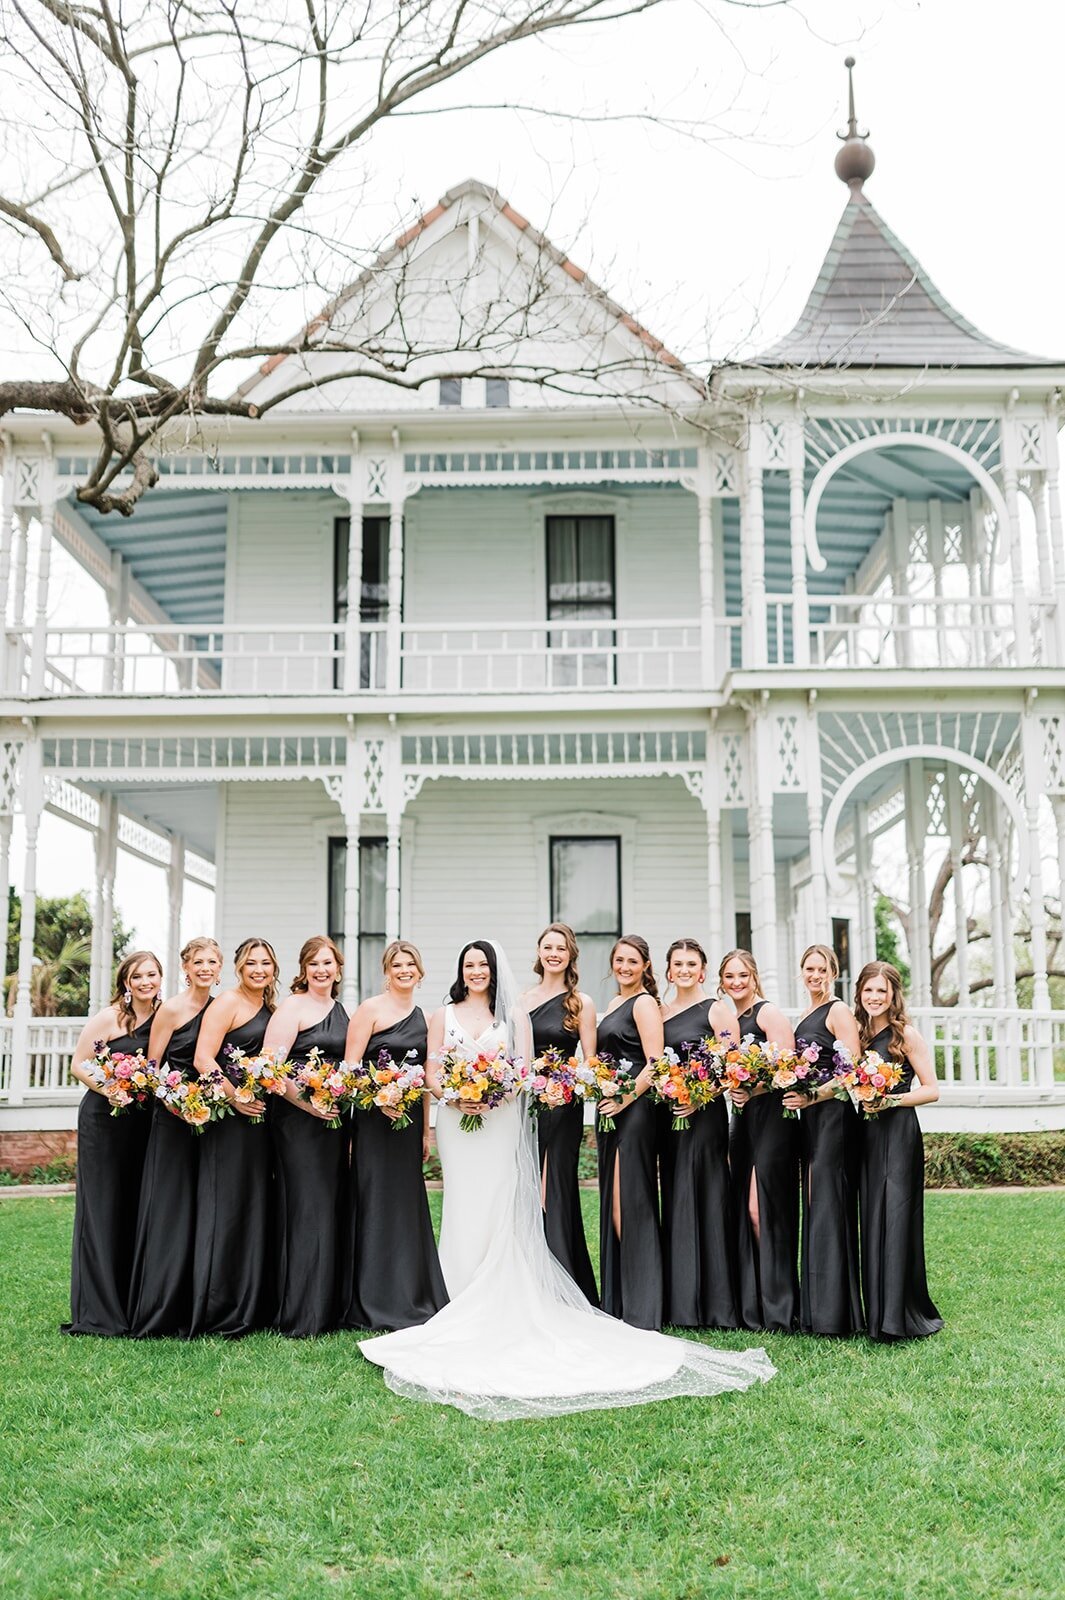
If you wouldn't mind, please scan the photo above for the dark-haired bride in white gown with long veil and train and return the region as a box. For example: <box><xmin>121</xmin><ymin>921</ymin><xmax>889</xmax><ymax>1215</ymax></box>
<box><xmin>360</xmin><ymin>939</ymin><xmax>776</xmax><ymax>1421</ymax></box>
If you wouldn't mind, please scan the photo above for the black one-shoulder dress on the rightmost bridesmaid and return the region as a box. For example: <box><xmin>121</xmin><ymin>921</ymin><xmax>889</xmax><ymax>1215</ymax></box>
<box><xmin>859</xmin><ymin>1027</ymin><xmax>943</xmax><ymax>1342</ymax></box>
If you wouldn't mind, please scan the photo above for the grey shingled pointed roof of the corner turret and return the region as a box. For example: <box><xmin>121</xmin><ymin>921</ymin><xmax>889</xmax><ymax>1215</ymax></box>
<box><xmin>752</xmin><ymin>184</ymin><xmax>1062</xmax><ymax>368</ymax></box>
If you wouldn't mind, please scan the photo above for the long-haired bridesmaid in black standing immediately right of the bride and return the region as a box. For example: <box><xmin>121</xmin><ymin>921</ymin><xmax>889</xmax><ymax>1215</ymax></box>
<box><xmin>521</xmin><ymin>922</ymin><xmax>600</xmax><ymax>1306</ymax></box>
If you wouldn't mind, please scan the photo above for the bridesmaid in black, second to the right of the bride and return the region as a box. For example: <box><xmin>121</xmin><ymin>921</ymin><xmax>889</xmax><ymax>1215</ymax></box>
<box><xmin>596</xmin><ymin>934</ymin><xmax>664</xmax><ymax>1328</ymax></box>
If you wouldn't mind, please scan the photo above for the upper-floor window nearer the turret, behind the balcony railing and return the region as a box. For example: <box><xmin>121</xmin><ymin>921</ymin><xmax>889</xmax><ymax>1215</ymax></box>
<box><xmin>545</xmin><ymin>517</ymin><xmax>616</xmax><ymax>688</ymax></box>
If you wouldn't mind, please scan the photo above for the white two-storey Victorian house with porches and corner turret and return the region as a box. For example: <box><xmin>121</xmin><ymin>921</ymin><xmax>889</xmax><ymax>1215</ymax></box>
<box><xmin>0</xmin><ymin>103</ymin><xmax>1065</xmax><ymax>1128</ymax></box>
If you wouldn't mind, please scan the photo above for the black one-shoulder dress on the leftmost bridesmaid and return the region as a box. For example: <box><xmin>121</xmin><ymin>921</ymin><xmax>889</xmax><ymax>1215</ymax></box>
<box><xmin>62</xmin><ymin>1018</ymin><xmax>152</xmax><ymax>1338</ymax></box>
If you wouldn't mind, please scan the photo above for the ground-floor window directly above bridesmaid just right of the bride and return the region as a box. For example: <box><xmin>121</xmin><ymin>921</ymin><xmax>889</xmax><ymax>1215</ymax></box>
<box><xmin>550</xmin><ymin>835</ymin><xmax>622</xmax><ymax>1010</ymax></box>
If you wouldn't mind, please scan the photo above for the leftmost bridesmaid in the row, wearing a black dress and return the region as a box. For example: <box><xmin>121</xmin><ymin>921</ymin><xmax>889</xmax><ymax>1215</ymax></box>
<box><xmin>62</xmin><ymin>950</ymin><xmax>163</xmax><ymax>1338</ymax></box>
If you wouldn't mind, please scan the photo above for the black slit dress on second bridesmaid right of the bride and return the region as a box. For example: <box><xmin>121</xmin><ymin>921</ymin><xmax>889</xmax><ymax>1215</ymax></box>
<box><xmin>596</xmin><ymin>995</ymin><xmax>664</xmax><ymax>1328</ymax></box>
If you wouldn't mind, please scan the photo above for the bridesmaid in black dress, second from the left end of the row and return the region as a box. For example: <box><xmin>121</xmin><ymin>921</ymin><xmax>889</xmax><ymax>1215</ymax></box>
<box><xmin>130</xmin><ymin>938</ymin><xmax>222</xmax><ymax>1339</ymax></box>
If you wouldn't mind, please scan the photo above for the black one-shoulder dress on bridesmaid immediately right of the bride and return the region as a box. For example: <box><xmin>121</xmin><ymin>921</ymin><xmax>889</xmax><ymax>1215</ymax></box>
<box><xmin>529</xmin><ymin>995</ymin><xmax>600</xmax><ymax>1306</ymax></box>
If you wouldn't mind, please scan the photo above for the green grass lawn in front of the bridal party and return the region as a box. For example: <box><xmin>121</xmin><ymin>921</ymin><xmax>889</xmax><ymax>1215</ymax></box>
<box><xmin>0</xmin><ymin>1192</ymin><xmax>1065</xmax><ymax>1600</ymax></box>
